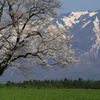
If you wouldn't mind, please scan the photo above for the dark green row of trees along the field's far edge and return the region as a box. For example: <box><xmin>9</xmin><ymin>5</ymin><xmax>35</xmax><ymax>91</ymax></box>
<box><xmin>2</xmin><ymin>78</ymin><xmax>100</xmax><ymax>89</ymax></box>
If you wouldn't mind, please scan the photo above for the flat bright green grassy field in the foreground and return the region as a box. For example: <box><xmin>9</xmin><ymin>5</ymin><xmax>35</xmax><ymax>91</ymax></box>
<box><xmin>0</xmin><ymin>87</ymin><xmax>100</xmax><ymax>100</ymax></box>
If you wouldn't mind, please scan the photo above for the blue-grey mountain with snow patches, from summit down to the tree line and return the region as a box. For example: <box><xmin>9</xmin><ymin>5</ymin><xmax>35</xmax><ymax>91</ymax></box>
<box><xmin>0</xmin><ymin>10</ymin><xmax>100</xmax><ymax>80</ymax></box>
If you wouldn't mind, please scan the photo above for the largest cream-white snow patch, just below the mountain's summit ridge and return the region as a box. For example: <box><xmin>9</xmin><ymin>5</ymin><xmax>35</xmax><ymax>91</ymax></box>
<box><xmin>56</xmin><ymin>11</ymin><xmax>98</xmax><ymax>28</ymax></box>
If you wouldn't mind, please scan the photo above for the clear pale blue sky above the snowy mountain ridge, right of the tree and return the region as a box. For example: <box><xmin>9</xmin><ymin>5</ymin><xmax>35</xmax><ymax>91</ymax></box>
<box><xmin>60</xmin><ymin>0</ymin><xmax>100</xmax><ymax>12</ymax></box>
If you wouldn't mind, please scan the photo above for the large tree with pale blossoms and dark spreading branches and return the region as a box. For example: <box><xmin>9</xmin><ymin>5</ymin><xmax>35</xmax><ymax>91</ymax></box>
<box><xmin>0</xmin><ymin>0</ymin><xmax>74</xmax><ymax>75</ymax></box>
